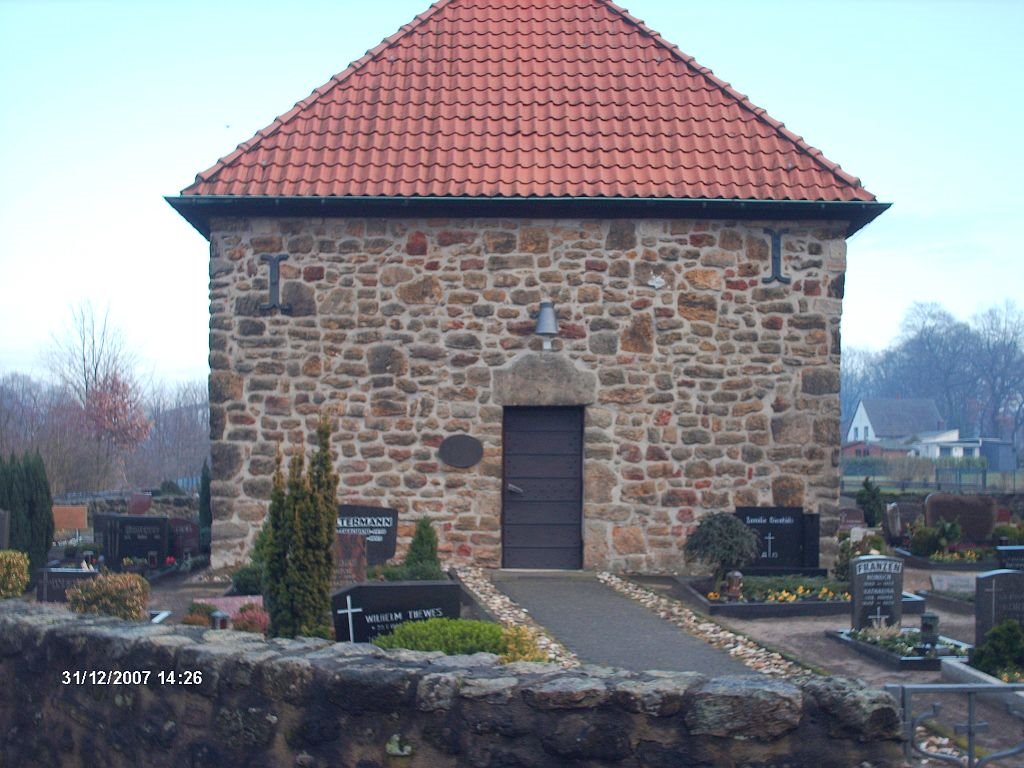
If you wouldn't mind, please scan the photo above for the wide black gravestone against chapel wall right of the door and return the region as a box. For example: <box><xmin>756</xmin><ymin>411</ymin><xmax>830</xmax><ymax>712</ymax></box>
<box><xmin>736</xmin><ymin>507</ymin><xmax>825</xmax><ymax>575</ymax></box>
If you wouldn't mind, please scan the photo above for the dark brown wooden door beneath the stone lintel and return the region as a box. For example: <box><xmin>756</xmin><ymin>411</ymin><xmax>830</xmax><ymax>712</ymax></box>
<box><xmin>502</xmin><ymin>407</ymin><xmax>583</xmax><ymax>569</ymax></box>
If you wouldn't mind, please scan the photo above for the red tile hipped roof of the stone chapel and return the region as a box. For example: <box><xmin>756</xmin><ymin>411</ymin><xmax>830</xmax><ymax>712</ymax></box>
<box><xmin>182</xmin><ymin>0</ymin><xmax>874</xmax><ymax>202</ymax></box>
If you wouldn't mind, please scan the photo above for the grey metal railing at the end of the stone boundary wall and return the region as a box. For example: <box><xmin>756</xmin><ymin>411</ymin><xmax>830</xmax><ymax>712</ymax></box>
<box><xmin>886</xmin><ymin>683</ymin><xmax>1024</xmax><ymax>768</ymax></box>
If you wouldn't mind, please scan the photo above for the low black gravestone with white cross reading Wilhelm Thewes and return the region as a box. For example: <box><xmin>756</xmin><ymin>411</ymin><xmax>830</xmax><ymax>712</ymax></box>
<box><xmin>331</xmin><ymin>582</ymin><xmax>461</xmax><ymax>643</ymax></box>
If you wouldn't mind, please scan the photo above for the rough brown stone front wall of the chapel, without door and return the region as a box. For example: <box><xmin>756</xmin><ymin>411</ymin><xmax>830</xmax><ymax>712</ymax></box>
<box><xmin>210</xmin><ymin>218</ymin><xmax>846</xmax><ymax>570</ymax></box>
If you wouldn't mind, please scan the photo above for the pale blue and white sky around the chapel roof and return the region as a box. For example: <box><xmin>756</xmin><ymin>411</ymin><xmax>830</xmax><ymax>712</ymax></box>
<box><xmin>0</xmin><ymin>0</ymin><xmax>1024</xmax><ymax>383</ymax></box>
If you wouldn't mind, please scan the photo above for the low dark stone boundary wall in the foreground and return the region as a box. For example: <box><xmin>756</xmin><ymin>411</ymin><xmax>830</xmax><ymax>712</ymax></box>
<box><xmin>0</xmin><ymin>600</ymin><xmax>901</xmax><ymax>768</ymax></box>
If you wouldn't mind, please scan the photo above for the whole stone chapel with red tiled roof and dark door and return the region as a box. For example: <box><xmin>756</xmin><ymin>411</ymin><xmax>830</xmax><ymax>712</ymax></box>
<box><xmin>169</xmin><ymin>0</ymin><xmax>888</xmax><ymax>571</ymax></box>
